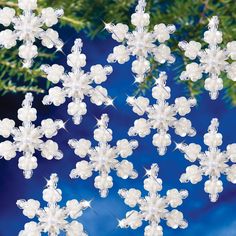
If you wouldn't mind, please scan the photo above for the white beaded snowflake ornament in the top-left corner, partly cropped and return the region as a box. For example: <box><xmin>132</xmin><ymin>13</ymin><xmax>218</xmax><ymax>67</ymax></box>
<box><xmin>0</xmin><ymin>0</ymin><xmax>63</xmax><ymax>67</ymax></box>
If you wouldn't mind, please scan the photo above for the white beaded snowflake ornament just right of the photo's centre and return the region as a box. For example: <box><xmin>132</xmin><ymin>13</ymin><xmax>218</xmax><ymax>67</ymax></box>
<box><xmin>127</xmin><ymin>72</ymin><xmax>196</xmax><ymax>155</ymax></box>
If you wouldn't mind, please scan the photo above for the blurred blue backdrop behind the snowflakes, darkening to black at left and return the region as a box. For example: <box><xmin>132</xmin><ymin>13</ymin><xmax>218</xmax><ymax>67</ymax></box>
<box><xmin>0</xmin><ymin>26</ymin><xmax>236</xmax><ymax>236</ymax></box>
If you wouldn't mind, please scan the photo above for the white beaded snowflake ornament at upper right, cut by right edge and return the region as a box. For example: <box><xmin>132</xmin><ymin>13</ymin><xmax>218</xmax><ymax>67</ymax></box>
<box><xmin>179</xmin><ymin>16</ymin><xmax>236</xmax><ymax>100</ymax></box>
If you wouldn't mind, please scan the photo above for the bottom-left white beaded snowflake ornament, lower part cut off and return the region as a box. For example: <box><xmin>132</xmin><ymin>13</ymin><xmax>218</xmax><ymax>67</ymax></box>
<box><xmin>16</xmin><ymin>174</ymin><xmax>90</xmax><ymax>236</ymax></box>
